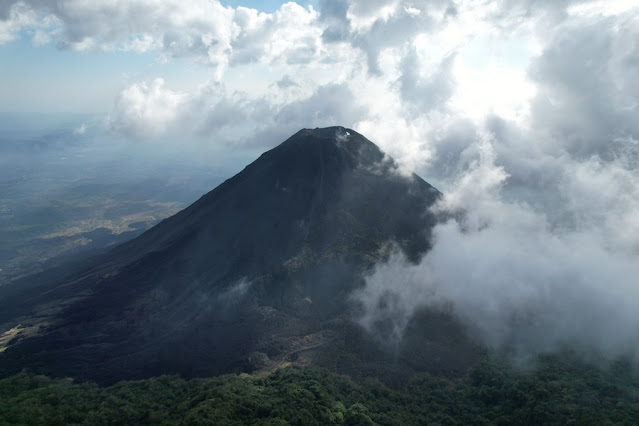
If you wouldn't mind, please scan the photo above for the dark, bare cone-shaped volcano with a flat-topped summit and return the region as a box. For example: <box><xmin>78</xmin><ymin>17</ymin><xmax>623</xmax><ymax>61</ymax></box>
<box><xmin>0</xmin><ymin>127</ymin><xmax>476</xmax><ymax>381</ymax></box>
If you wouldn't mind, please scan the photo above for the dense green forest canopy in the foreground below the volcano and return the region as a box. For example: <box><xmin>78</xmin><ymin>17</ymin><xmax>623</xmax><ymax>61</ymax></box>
<box><xmin>0</xmin><ymin>359</ymin><xmax>639</xmax><ymax>425</ymax></box>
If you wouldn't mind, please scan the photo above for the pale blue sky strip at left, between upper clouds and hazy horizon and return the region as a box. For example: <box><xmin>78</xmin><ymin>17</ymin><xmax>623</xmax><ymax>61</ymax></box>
<box><xmin>0</xmin><ymin>32</ymin><xmax>213</xmax><ymax>113</ymax></box>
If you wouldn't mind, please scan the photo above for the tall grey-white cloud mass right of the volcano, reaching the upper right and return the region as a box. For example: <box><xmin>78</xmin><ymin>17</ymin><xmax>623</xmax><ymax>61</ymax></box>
<box><xmin>353</xmin><ymin>0</ymin><xmax>639</xmax><ymax>359</ymax></box>
